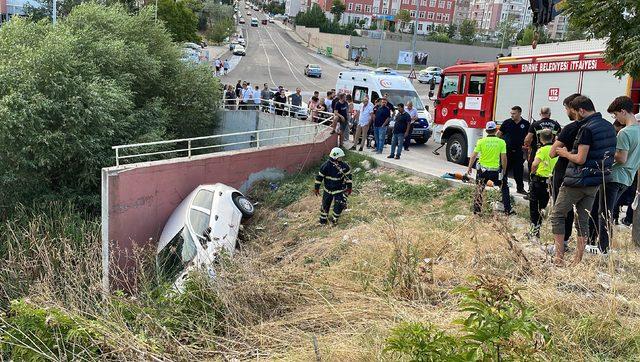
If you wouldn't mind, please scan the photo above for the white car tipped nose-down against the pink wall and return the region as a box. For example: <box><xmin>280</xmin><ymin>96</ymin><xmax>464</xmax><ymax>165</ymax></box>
<box><xmin>156</xmin><ymin>183</ymin><xmax>254</xmax><ymax>291</ymax></box>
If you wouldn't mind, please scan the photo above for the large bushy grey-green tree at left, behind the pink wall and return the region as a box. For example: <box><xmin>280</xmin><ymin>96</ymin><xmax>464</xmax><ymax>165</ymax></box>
<box><xmin>0</xmin><ymin>3</ymin><xmax>220</xmax><ymax>211</ymax></box>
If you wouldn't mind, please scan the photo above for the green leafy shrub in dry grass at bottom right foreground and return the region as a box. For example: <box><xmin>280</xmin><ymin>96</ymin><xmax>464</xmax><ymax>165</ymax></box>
<box><xmin>385</xmin><ymin>277</ymin><xmax>551</xmax><ymax>361</ymax></box>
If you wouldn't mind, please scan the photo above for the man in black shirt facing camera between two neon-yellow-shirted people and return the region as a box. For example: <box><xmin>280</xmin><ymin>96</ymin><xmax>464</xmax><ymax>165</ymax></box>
<box><xmin>498</xmin><ymin>106</ymin><xmax>530</xmax><ymax>194</ymax></box>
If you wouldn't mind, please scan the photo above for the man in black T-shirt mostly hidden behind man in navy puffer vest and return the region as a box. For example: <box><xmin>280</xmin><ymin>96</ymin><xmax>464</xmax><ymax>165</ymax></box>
<box><xmin>550</xmin><ymin>93</ymin><xmax>584</xmax><ymax>250</ymax></box>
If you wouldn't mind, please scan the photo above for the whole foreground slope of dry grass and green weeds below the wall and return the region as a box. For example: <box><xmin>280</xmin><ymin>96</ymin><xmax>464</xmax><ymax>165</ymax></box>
<box><xmin>0</xmin><ymin>154</ymin><xmax>640</xmax><ymax>361</ymax></box>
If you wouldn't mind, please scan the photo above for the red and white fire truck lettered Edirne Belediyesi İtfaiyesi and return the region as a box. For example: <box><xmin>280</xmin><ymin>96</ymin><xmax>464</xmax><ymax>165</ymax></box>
<box><xmin>429</xmin><ymin>40</ymin><xmax>640</xmax><ymax>165</ymax></box>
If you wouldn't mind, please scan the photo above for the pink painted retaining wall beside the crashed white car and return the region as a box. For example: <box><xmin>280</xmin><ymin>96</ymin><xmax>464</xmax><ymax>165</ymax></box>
<box><xmin>103</xmin><ymin>132</ymin><xmax>336</xmax><ymax>286</ymax></box>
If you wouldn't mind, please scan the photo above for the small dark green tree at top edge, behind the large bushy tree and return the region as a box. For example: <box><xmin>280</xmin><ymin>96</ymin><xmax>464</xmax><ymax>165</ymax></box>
<box><xmin>158</xmin><ymin>0</ymin><xmax>200</xmax><ymax>42</ymax></box>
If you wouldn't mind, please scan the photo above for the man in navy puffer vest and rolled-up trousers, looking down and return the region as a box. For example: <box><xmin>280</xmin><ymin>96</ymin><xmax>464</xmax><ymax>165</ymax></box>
<box><xmin>551</xmin><ymin>96</ymin><xmax>616</xmax><ymax>266</ymax></box>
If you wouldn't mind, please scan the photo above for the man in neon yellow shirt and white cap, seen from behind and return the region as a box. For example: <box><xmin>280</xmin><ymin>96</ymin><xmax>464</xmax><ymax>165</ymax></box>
<box><xmin>467</xmin><ymin>122</ymin><xmax>513</xmax><ymax>215</ymax></box>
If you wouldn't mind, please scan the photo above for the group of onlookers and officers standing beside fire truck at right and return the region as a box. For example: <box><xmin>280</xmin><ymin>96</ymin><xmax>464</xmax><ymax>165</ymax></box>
<box><xmin>467</xmin><ymin>94</ymin><xmax>640</xmax><ymax>264</ymax></box>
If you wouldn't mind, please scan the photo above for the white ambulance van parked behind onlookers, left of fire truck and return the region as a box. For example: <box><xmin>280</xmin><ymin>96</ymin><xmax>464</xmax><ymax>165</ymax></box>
<box><xmin>336</xmin><ymin>68</ymin><xmax>432</xmax><ymax>144</ymax></box>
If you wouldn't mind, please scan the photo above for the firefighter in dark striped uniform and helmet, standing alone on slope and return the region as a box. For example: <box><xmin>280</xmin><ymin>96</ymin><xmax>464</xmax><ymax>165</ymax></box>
<box><xmin>314</xmin><ymin>147</ymin><xmax>352</xmax><ymax>225</ymax></box>
